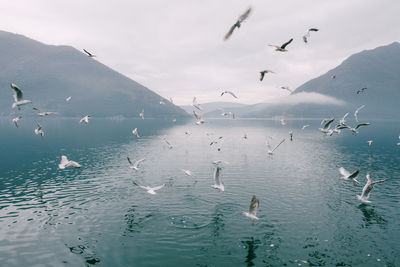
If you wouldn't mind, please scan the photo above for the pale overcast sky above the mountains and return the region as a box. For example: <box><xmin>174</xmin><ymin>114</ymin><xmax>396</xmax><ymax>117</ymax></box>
<box><xmin>0</xmin><ymin>0</ymin><xmax>400</xmax><ymax>104</ymax></box>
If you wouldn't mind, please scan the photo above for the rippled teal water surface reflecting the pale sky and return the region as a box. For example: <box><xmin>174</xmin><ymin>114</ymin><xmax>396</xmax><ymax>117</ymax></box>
<box><xmin>0</xmin><ymin>119</ymin><xmax>400</xmax><ymax>266</ymax></box>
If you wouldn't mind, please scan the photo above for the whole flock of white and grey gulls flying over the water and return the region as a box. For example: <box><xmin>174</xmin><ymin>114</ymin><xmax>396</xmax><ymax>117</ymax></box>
<box><xmin>6</xmin><ymin>8</ymin><xmax>400</xmax><ymax>224</ymax></box>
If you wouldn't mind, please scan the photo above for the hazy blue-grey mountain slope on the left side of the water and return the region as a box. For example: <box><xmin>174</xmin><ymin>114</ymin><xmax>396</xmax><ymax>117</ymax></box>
<box><xmin>0</xmin><ymin>31</ymin><xmax>187</xmax><ymax>118</ymax></box>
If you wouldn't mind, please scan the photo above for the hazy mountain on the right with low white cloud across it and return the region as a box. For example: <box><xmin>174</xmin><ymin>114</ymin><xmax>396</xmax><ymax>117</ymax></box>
<box><xmin>204</xmin><ymin>42</ymin><xmax>400</xmax><ymax>119</ymax></box>
